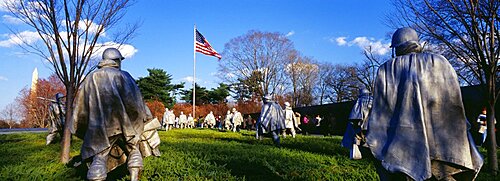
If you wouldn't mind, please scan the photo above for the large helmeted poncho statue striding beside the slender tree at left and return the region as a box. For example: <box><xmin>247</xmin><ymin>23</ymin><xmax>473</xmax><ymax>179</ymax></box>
<box><xmin>70</xmin><ymin>48</ymin><xmax>147</xmax><ymax>180</ymax></box>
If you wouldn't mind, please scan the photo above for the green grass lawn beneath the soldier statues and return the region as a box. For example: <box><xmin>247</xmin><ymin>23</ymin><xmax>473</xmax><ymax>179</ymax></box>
<box><xmin>0</xmin><ymin>129</ymin><xmax>493</xmax><ymax>180</ymax></box>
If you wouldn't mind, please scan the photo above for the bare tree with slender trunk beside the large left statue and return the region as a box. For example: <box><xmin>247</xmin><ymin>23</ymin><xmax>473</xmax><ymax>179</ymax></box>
<box><xmin>4</xmin><ymin>0</ymin><xmax>137</xmax><ymax>163</ymax></box>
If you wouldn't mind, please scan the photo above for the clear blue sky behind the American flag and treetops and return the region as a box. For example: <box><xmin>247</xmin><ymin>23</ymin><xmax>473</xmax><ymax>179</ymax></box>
<box><xmin>0</xmin><ymin>0</ymin><xmax>394</xmax><ymax>109</ymax></box>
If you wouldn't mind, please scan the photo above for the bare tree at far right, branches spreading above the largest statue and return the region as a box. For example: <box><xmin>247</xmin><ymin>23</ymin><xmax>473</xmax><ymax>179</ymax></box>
<box><xmin>389</xmin><ymin>0</ymin><xmax>500</xmax><ymax>175</ymax></box>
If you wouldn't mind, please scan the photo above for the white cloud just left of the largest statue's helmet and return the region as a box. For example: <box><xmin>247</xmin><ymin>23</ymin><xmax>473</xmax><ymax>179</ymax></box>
<box><xmin>330</xmin><ymin>36</ymin><xmax>391</xmax><ymax>55</ymax></box>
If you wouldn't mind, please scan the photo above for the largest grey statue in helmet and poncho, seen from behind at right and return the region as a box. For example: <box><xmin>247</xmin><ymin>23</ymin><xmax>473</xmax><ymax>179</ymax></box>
<box><xmin>366</xmin><ymin>28</ymin><xmax>483</xmax><ymax>180</ymax></box>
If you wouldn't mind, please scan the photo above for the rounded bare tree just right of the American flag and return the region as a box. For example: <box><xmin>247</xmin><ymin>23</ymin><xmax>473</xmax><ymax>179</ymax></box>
<box><xmin>219</xmin><ymin>30</ymin><xmax>294</xmax><ymax>99</ymax></box>
